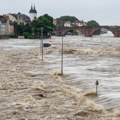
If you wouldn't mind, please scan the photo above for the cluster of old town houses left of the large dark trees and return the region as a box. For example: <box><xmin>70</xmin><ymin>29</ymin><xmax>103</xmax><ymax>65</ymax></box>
<box><xmin>0</xmin><ymin>13</ymin><xmax>31</xmax><ymax>38</ymax></box>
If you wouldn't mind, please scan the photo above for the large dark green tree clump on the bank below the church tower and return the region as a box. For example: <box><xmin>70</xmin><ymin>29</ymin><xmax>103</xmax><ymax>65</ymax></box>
<box><xmin>17</xmin><ymin>14</ymin><xmax>54</xmax><ymax>38</ymax></box>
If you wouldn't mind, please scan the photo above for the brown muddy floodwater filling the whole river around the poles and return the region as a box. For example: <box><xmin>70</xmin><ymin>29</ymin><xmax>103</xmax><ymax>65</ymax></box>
<box><xmin>0</xmin><ymin>36</ymin><xmax>120</xmax><ymax>120</ymax></box>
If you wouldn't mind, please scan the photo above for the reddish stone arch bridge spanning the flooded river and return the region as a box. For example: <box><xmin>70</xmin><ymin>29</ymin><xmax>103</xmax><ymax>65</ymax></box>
<box><xmin>53</xmin><ymin>26</ymin><xmax>120</xmax><ymax>37</ymax></box>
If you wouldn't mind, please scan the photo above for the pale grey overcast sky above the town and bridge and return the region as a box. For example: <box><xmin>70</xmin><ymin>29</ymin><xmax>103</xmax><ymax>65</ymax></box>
<box><xmin>0</xmin><ymin>0</ymin><xmax>120</xmax><ymax>25</ymax></box>
